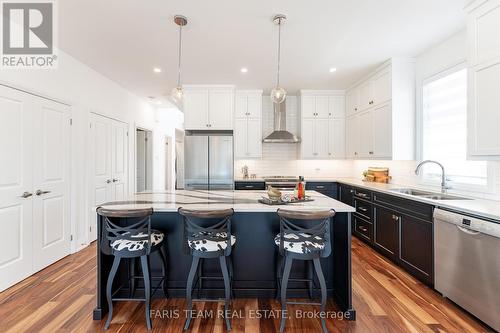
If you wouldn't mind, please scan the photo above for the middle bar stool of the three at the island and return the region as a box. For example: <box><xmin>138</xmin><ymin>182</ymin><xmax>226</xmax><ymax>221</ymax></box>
<box><xmin>179</xmin><ymin>207</ymin><xmax>236</xmax><ymax>331</ymax></box>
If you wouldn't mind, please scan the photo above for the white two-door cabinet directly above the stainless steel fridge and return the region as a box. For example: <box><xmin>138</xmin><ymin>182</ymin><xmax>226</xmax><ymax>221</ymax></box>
<box><xmin>183</xmin><ymin>86</ymin><xmax>234</xmax><ymax>130</ymax></box>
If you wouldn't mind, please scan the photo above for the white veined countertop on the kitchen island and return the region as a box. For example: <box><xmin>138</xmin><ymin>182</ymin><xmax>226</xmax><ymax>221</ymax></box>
<box><xmin>101</xmin><ymin>190</ymin><xmax>355</xmax><ymax>213</ymax></box>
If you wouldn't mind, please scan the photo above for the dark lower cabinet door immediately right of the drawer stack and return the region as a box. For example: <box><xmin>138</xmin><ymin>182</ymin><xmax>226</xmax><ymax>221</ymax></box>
<box><xmin>373</xmin><ymin>206</ymin><xmax>400</xmax><ymax>260</ymax></box>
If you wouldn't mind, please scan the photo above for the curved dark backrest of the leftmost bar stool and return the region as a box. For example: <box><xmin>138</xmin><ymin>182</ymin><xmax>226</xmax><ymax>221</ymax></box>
<box><xmin>97</xmin><ymin>207</ymin><xmax>153</xmax><ymax>255</ymax></box>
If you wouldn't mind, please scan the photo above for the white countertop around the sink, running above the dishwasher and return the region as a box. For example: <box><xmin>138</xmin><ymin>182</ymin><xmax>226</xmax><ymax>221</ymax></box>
<box><xmin>334</xmin><ymin>178</ymin><xmax>500</xmax><ymax>222</ymax></box>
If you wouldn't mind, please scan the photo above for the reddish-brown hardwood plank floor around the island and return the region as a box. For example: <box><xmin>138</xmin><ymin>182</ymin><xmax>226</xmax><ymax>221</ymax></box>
<box><xmin>0</xmin><ymin>238</ymin><xmax>489</xmax><ymax>333</ymax></box>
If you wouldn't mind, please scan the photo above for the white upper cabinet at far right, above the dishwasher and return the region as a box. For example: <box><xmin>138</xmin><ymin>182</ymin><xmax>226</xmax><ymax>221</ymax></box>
<box><xmin>466</xmin><ymin>0</ymin><xmax>500</xmax><ymax>160</ymax></box>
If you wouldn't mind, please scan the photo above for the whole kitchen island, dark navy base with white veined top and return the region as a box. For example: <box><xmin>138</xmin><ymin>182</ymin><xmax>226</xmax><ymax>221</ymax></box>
<box><xmin>93</xmin><ymin>190</ymin><xmax>355</xmax><ymax>320</ymax></box>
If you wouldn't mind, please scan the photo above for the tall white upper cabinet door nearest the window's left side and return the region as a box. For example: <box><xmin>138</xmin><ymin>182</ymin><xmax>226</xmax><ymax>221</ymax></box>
<box><xmin>370</xmin><ymin>104</ymin><xmax>392</xmax><ymax>159</ymax></box>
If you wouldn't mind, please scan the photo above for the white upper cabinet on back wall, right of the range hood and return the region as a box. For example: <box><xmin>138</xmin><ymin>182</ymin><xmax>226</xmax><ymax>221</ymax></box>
<box><xmin>300</xmin><ymin>90</ymin><xmax>345</xmax><ymax>159</ymax></box>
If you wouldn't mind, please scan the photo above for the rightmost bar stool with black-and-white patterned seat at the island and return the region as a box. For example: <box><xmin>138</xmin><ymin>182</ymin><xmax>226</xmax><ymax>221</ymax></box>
<box><xmin>274</xmin><ymin>209</ymin><xmax>335</xmax><ymax>333</ymax></box>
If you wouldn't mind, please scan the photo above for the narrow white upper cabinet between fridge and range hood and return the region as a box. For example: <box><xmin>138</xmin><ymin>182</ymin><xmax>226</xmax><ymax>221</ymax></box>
<box><xmin>233</xmin><ymin>90</ymin><xmax>262</xmax><ymax>159</ymax></box>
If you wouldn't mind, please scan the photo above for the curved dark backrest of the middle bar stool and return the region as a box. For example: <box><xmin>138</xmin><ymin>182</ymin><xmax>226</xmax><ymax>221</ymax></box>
<box><xmin>179</xmin><ymin>207</ymin><xmax>234</xmax><ymax>256</ymax></box>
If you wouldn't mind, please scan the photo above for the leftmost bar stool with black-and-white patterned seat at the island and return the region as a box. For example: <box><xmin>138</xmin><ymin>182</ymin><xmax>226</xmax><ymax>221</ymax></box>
<box><xmin>97</xmin><ymin>207</ymin><xmax>167</xmax><ymax>330</ymax></box>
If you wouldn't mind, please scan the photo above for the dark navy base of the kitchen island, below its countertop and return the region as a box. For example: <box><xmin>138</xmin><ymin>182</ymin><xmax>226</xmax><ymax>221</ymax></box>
<box><xmin>93</xmin><ymin>212</ymin><xmax>356</xmax><ymax>320</ymax></box>
